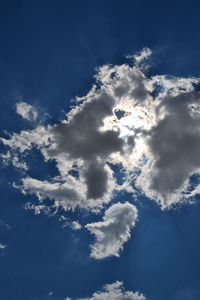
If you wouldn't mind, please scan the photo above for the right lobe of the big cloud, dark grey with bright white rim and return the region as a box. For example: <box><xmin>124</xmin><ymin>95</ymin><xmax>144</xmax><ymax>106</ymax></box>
<box><xmin>138</xmin><ymin>83</ymin><xmax>200</xmax><ymax>208</ymax></box>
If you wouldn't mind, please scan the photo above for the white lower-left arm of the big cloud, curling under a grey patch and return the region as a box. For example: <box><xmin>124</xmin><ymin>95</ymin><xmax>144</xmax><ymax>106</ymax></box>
<box><xmin>13</xmin><ymin>166</ymin><xmax>114</xmax><ymax>212</ymax></box>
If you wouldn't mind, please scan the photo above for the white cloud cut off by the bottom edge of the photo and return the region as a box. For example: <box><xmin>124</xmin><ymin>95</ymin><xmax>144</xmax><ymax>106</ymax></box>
<box><xmin>65</xmin><ymin>281</ymin><xmax>146</xmax><ymax>300</ymax></box>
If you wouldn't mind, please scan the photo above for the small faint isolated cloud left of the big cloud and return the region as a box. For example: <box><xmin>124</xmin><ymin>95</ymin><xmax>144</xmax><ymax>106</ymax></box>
<box><xmin>16</xmin><ymin>101</ymin><xmax>38</xmax><ymax>121</ymax></box>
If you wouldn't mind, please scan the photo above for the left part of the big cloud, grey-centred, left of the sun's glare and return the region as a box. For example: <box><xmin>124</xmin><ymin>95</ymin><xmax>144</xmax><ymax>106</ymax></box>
<box><xmin>1</xmin><ymin>49</ymin><xmax>151</xmax><ymax>210</ymax></box>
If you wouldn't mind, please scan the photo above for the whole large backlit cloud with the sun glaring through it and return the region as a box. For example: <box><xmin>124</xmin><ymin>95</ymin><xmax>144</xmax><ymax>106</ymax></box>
<box><xmin>0</xmin><ymin>48</ymin><xmax>200</xmax><ymax>211</ymax></box>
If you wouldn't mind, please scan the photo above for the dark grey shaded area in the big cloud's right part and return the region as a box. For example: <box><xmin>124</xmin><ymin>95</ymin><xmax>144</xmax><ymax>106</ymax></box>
<box><xmin>149</xmin><ymin>91</ymin><xmax>200</xmax><ymax>194</ymax></box>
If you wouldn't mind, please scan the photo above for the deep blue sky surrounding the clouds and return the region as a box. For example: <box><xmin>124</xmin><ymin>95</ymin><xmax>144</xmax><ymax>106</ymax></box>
<box><xmin>0</xmin><ymin>0</ymin><xmax>200</xmax><ymax>300</ymax></box>
